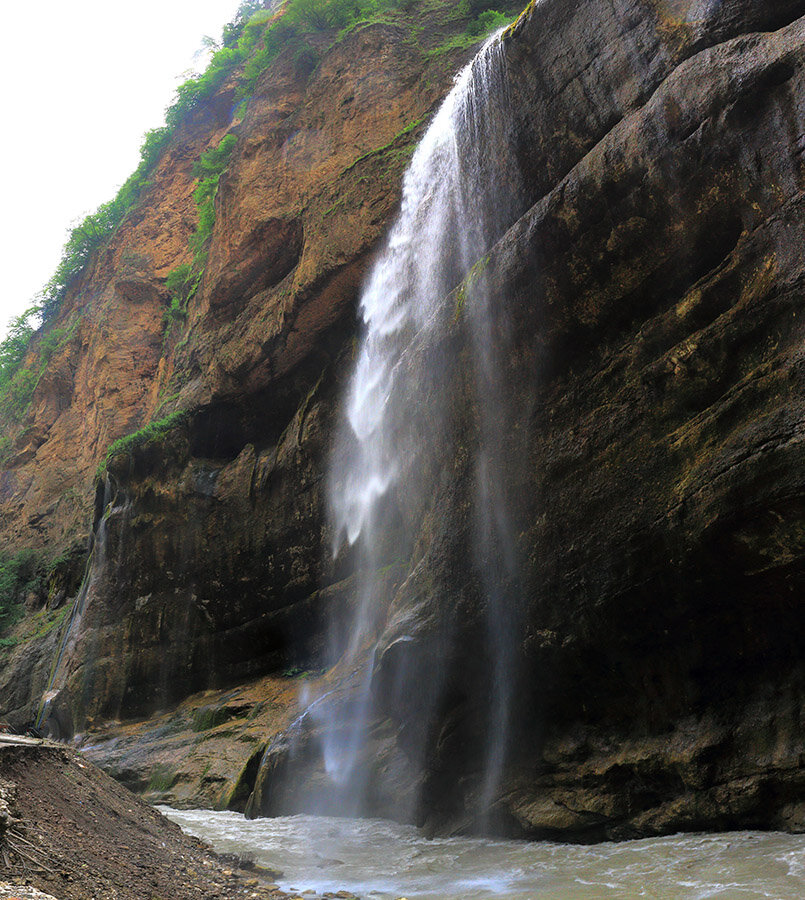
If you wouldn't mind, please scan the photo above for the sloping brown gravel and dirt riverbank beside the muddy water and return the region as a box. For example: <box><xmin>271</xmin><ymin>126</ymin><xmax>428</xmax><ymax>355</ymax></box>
<box><xmin>0</xmin><ymin>736</ymin><xmax>351</xmax><ymax>900</ymax></box>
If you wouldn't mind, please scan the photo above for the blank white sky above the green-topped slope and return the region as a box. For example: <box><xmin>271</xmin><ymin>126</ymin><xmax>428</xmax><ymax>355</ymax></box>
<box><xmin>0</xmin><ymin>0</ymin><xmax>245</xmax><ymax>337</ymax></box>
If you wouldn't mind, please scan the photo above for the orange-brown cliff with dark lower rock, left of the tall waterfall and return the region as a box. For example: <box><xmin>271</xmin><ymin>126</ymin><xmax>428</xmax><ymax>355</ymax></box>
<box><xmin>0</xmin><ymin>4</ymin><xmax>517</xmax><ymax>800</ymax></box>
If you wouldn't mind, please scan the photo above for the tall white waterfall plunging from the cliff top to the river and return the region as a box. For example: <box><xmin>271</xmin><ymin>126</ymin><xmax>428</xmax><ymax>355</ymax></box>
<box><xmin>280</xmin><ymin>29</ymin><xmax>520</xmax><ymax>821</ymax></box>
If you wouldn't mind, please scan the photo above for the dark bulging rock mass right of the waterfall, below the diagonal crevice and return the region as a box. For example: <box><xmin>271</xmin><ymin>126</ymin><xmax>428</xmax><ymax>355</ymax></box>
<box><xmin>490</xmin><ymin>4</ymin><xmax>805</xmax><ymax>836</ymax></box>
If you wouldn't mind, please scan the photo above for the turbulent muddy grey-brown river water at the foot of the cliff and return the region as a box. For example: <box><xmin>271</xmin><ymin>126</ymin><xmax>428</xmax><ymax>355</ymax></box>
<box><xmin>163</xmin><ymin>808</ymin><xmax>805</xmax><ymax>900</ymax></box>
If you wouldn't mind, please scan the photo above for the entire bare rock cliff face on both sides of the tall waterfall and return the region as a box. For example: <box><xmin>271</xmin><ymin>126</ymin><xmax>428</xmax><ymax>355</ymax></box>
<box><xmin>0</xmin><ymin>0</ymin><xmax>805</xmax><ymax>839</ymax></box>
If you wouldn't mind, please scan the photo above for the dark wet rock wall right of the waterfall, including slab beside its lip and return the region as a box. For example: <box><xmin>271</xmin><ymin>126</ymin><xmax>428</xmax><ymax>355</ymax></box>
<box><xmin>254</xmin><ymin>3</ymin><xmax>805</xmax><ymax>840</ymax></box>
